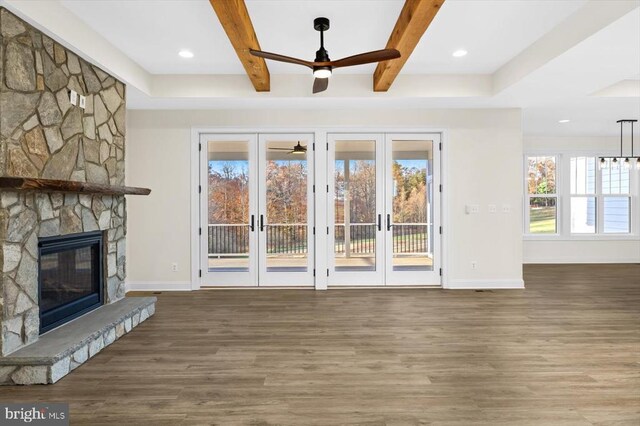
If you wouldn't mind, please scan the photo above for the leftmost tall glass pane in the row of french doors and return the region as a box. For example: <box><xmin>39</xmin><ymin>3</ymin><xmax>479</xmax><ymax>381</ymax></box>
<box><xmin>207</xmin><ymin>141</ymin><xmax>250</xmax><ymax>271</ymax></box>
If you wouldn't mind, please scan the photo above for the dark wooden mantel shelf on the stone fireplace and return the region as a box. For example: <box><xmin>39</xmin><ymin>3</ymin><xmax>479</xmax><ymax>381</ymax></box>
<box><xmin>0</xmin><ymin>177</ymin><xmax>151</xmax><ymax>195</ymax></box>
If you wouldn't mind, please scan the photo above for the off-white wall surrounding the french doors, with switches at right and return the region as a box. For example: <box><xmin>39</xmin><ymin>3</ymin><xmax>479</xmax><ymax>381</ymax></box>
<box><xmin>126</xmin><ymin>109</ymin><xmax>523</xmax><ymax>289</ymax></box>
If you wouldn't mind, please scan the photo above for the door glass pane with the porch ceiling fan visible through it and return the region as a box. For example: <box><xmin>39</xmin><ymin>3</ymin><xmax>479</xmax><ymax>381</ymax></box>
<box><xmin>264</xmin><ymin>141</ymin><xmax>308</xmax><ymax>272</ymax></box>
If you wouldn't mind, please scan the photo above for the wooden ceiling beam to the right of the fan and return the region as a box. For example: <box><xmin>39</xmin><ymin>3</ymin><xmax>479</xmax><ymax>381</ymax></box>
<box><xmin>373</xmin><ymin>0</ymin><xmax>445</xmax><ymax>92</ymax></box>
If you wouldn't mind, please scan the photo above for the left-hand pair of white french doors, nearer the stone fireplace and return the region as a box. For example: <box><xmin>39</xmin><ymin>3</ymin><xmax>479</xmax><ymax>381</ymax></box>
<box><xmin>200</xmin><ymin>134</ymin><xmax>315</xmax><ymax>287</ymax></box>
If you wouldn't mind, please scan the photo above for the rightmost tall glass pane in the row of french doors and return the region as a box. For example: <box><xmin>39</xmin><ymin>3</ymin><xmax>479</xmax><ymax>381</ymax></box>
<box><xmin>391</xmin><ymin>141</ymin><xmax>434</xmax><ymax>271</ymax></box>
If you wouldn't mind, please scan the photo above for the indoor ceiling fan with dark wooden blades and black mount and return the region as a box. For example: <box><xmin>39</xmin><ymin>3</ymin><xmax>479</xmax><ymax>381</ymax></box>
<box><xmin>249</xmin><ymin>18</ymin><xmax>400</xmax><ymax>93</ymax></box>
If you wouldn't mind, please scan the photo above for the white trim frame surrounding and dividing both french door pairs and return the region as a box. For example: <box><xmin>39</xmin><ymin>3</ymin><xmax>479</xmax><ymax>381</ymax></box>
<box><xmin>190</xmin><ymin>125</ymin><xmax>452</xmax><ymax>290</ymax></box>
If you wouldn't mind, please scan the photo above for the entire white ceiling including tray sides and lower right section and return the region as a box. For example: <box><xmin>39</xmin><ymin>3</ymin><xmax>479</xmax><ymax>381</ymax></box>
<box><xmin>0</xmin><ymin>0</ymin><xmax>640</xmax><ymax>136</ymax></box>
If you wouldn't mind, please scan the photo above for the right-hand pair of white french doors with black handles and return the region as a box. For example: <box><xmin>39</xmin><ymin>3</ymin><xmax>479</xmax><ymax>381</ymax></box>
<box><xmin>327</xmin><ymin>134</ymin><xmax>440</xmax><ymax>286</ymax></box>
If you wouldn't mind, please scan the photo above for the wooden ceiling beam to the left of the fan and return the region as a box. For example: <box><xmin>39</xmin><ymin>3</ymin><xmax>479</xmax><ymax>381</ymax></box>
<box><xmin>209</xmin><ymin>0</ymin><xmax>271</xmax><ymax>92</ymax></box>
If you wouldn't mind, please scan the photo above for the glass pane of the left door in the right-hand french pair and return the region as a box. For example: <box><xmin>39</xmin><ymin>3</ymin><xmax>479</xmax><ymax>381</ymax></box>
<box><xmin>334</xmin><ymin>141</ymin><xmax>376</xmax><ymax>271</ymax></box>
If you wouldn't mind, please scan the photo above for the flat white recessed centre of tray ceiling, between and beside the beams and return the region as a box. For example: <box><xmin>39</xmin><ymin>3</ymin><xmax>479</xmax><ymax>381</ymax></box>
<box><xmin>62</xmin><ymin>0</ymin><xmax>586</xmax><ymax>74</ymax></box>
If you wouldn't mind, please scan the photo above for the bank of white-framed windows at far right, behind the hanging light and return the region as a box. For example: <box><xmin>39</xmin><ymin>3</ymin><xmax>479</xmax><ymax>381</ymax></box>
<box><xmin>525</xmin><ymin>155</ymin><xmax>640</xmax><ymax>236</ymax></box>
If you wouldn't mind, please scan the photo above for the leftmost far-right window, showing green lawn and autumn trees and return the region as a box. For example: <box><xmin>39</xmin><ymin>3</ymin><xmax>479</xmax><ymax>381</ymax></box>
<box><xmin>527</xmin><ymin>156</ymin><xmax>558</xmax><ymax>234</ymax></box>
